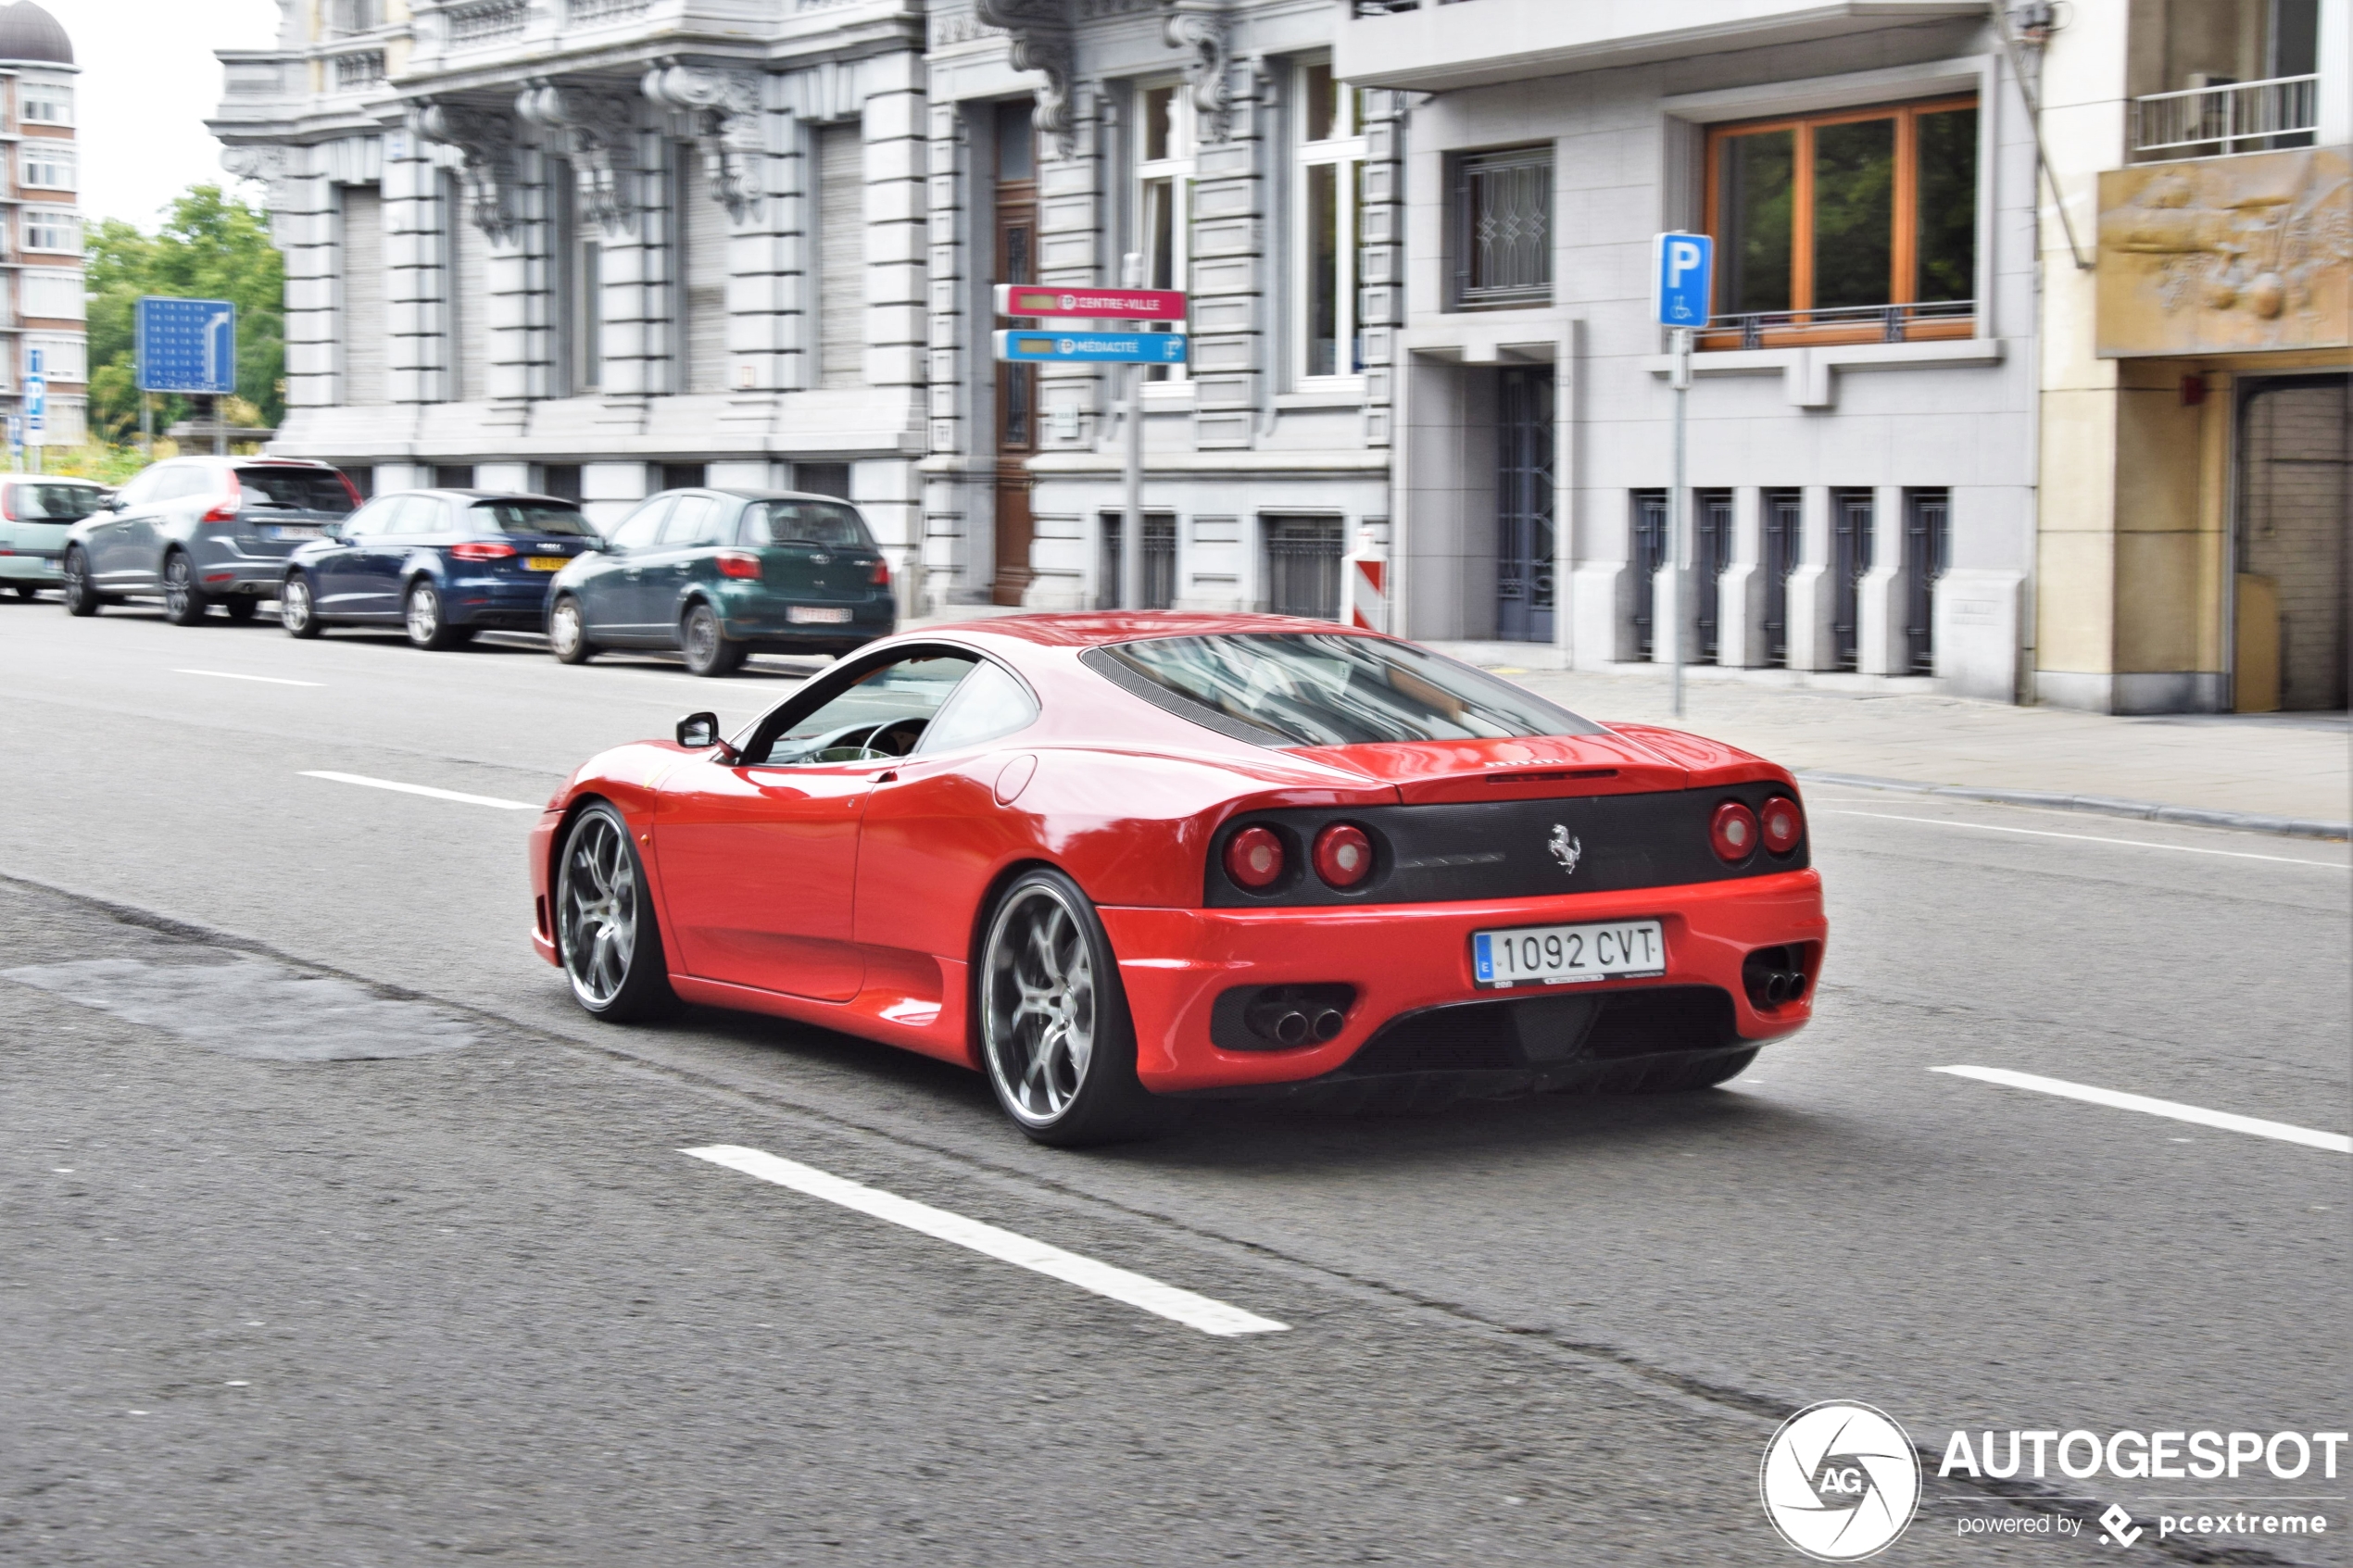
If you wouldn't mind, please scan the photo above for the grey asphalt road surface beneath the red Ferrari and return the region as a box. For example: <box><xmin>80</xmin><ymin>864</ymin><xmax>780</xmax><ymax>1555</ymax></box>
<box><xmin>0</xmin><ymin>602</ymin><xmax>2353</xmax><ymax>1563</ymax></box>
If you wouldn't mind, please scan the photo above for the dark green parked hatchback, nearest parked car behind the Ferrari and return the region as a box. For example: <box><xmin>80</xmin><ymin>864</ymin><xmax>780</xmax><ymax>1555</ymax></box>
<box><xmin>548</xmin><ymin>489</ymin><xmax>899</xmax><ymax>674</ymax></box>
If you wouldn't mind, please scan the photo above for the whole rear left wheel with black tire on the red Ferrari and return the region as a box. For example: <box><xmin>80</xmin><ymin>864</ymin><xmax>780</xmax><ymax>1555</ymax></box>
<box><xmin>975</xmin><ymin>868</ymin><xmax>1179</xmax><ymax>1148</ymax></box>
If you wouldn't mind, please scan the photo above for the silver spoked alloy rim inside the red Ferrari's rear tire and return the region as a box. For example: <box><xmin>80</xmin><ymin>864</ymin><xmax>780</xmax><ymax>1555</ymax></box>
<box><xmin>981</xmin><ymin>884</ymin><xmax>1097</xmax><ymax>1126</ymax></box>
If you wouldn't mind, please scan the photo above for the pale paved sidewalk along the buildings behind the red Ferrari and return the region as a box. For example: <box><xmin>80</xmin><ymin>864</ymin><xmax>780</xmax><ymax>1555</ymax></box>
<box><xmin>906</xmin><ymin>607</ymin><xmax>2353</xmax><ymax>837</ymax></box>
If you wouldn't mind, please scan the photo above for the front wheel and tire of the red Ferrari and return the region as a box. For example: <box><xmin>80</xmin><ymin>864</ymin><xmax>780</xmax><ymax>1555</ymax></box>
<box><xmin>555</xmin><ymin>802</ymin><xmax>678</xmax><ymax>1022</ymax></box>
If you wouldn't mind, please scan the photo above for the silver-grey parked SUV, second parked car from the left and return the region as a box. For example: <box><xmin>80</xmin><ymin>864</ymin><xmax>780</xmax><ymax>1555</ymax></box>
<box><xmin>61</xmin><ymin>458</ymin><xmax>360</xmax><ymax>625</ymax></box>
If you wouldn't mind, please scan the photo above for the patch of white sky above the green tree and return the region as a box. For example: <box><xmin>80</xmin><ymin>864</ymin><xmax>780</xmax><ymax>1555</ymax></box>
<box><xmin>38</xmin><ymin>0</ymin><xmax>278</xmax><ymax>231</ymax></box>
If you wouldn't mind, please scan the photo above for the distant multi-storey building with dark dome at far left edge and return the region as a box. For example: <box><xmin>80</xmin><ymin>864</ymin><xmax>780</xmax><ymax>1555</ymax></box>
<box><xmin>0</xmin><ymin>0</ymin><xmax>90</xmax><ymax>445</ymax></box>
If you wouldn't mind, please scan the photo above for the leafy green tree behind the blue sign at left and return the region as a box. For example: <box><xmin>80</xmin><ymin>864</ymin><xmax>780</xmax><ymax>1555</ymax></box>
<box><xmin>84</xmin><ymin>186</ymin><xmax>287</xmax><ymax>440</ymax></box>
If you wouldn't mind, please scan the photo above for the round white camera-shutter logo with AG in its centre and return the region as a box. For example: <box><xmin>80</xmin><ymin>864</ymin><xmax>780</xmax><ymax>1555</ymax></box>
<box><xmin>1757</xmin><ymin>1399</ymin><xmax>1920</xmax><ymax>1563</ymax></box>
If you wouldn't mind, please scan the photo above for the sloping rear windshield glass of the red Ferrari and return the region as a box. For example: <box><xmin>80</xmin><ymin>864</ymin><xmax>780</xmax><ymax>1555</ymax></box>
<box><xmin>1101</xmin><ymin>633</ymin><xmax>1600</xmax><ymax>746</ymax></box>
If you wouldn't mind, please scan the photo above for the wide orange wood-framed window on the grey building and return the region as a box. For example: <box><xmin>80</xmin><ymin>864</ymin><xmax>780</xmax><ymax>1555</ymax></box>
<box><xmin>1701</xmin><ymin>99</ymin><xmax>1977</xmax><ymax>348</ymax></box>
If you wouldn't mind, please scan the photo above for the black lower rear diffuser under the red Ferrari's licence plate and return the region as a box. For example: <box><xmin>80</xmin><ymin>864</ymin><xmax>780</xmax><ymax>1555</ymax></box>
<box><xmin>1339</xmin><ymin>985</ymin><xmax>1739</xmax><ymax>1077</ymax></box>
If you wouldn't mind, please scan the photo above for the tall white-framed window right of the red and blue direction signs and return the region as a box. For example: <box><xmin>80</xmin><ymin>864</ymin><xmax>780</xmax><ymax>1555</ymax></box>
<box><xmin>1297</xmin><ymin>66</ymin><xmax>1365</xmax><ymax>376</ymax></box>
